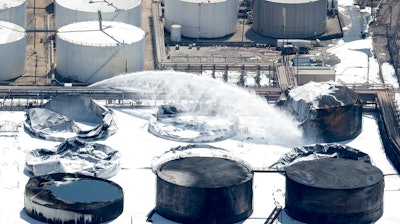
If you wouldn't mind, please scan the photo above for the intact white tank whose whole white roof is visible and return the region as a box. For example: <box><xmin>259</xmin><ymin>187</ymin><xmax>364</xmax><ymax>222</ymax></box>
<box><xmin>56</xmin><ymin>21</ymin><xmax>145</xmax><ymax>83</ymax></box>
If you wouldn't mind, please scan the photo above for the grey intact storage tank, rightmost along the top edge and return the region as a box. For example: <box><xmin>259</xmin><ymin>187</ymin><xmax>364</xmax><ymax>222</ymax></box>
<box><xmin>252</xmin><ymin>0</ymin><xmax>327</xmax><ymax>39</ymax></box>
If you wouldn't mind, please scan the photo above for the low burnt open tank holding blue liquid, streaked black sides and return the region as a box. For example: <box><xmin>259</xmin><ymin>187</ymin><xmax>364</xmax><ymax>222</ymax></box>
<box><xmin>25</xmin><ymin>173</ymin><xmax>124</xmax><ymax>224</ymax></box>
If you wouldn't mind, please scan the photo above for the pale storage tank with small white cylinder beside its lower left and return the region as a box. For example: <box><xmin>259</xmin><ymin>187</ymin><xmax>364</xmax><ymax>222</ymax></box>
<box><xmin>164</xmin><ymin>0</ymin><xmax>238</xmax><ymax>38</ymax></box>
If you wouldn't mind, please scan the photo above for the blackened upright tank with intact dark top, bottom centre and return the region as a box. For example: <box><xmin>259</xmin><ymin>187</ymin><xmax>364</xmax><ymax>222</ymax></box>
<box><xmin>156</xmin><ymin>157</ymin><xmax>253</xmax><ymax>223</ymax></box>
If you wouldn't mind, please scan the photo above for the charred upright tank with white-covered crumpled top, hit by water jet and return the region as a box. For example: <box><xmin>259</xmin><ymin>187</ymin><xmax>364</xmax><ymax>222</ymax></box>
<box><xmin>278</xmin><ymin>81</ymin><xmax>362</xmax><ymax>142</ymax></box>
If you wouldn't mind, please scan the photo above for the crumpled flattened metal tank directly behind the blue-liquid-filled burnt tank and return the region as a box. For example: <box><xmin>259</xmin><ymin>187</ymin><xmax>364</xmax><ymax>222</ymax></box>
<box><xmin>25</xmin><ymin>139</ymin><xmax>121</xmax><ymax>179</ymax></box>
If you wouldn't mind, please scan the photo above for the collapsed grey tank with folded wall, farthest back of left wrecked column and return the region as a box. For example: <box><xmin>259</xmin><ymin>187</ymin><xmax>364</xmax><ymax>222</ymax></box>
<box><xmin>24</xmin><ymin>94</ymin><xmax>117</xmax><ymax>141</ymax></box>
